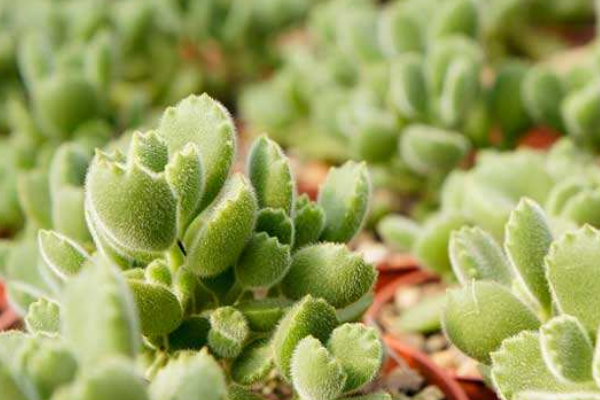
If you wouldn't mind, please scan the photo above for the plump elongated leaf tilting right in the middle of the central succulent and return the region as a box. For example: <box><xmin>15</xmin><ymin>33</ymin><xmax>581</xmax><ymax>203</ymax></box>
<box><xmin>185</xmin><ymin>175</ymin><xmax>258</xmax><ymax>277</ymax></box>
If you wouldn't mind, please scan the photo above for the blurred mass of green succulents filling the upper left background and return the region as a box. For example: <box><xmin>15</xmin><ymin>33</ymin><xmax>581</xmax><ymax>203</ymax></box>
<box><xmin>0</xmin><ymin>0</ymin><xmax>328</xmax><ymax>234</ymax></box>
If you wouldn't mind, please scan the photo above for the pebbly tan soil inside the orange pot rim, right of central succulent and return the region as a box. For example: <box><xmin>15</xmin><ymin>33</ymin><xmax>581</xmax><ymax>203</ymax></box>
<box><xmin>377</xmin><ymin>282</ymin><xmax>481</xmax><ymax>378</ymax></box>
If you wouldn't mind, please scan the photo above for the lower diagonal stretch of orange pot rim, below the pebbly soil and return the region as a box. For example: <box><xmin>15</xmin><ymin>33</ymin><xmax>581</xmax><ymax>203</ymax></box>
<box><xmin>383</xmin><ymin>335</ymin><xmax>469</xmax><ymax>400</ymax></box>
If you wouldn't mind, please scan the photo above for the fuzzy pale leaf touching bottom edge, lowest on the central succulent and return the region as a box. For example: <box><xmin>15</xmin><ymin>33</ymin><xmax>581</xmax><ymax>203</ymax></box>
<box><xmin>291</xmin><ymin>336</ymin><xmax>347</xmax><ymax>400</ymax></box>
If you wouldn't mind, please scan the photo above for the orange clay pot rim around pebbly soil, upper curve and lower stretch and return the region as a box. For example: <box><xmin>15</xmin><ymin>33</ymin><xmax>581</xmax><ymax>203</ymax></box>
<box><xmin>363</xmin><ymin>269</ymin><xmax>497</xmax><ymax>400</ymax></box>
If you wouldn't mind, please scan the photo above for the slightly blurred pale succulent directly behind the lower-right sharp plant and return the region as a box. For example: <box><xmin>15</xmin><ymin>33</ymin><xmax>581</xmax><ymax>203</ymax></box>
<box><xmin>377</xmin><ymin>138</ymin><xmax>600</xmax><ymax>281</ymax></box>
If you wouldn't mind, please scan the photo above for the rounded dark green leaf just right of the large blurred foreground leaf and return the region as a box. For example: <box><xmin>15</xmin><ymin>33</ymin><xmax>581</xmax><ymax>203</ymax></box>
<box><xmin>128</xmin><ymin>280</ymin><xmax>183</xmax><ymax>336</ymax></box>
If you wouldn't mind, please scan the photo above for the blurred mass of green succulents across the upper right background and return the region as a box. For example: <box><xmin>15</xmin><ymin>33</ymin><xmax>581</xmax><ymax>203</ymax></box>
<box><xmin>240</xmin><ymin>0</ymin><xmax>597</xmax><ymax>209</ymax></box>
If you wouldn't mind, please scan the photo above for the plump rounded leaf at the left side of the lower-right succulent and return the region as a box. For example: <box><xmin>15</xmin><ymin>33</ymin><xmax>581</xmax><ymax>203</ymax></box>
<box><xmin>442</xmin><ymin>282</ymin><xmax>540</xmax><ymax>364</ymax></box>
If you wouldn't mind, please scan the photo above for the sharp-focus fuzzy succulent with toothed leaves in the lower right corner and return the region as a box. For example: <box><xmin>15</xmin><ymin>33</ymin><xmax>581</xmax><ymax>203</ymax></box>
<box><xmin>443</xmin><ymin>198</ymin><xmax>600</xmax><ymax>400</ymax></box>
